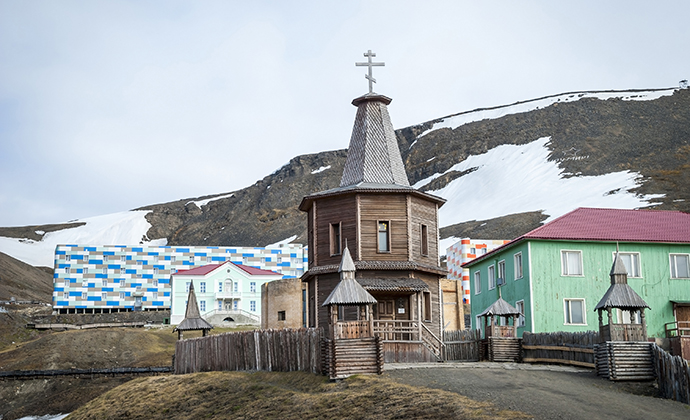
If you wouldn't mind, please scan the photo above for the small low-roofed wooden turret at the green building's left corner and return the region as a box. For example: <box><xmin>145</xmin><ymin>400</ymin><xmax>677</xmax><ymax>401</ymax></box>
<box><xmin>479</xmin><ymin>297</ymin><xmax>521</xmax><ymax>362</ymax></box>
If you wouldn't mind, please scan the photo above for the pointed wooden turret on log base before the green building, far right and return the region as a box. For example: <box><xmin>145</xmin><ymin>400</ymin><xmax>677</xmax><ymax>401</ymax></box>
<box><xmin>594</xmin><ymin>250</ymin><xmax>654</xmax><ymax>381</ymax></box>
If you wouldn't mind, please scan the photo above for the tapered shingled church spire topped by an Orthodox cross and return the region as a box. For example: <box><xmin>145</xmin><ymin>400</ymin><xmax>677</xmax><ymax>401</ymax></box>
<box><xmin>340</xmin><ymin>51</ymin><xmax>410</xmax><ymax>187</ymax></box>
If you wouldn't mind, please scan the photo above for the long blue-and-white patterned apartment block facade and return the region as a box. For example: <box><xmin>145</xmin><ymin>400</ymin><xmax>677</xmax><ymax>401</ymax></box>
<box><xmin>52</xmin><ymin>244</ymin><xmax>308</xmax><ymax>313</ymax></box>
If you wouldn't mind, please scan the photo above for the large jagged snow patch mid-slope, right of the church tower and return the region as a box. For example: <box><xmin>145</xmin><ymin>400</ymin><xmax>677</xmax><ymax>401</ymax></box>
<box><xmin>414</xmin><ymin>137</ymin><xmax>663</xmax><ymax>227</ymax></box>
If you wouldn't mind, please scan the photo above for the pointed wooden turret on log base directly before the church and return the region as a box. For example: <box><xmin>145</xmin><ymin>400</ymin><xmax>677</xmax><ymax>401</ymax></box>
<box><xmin>323</xmin><ymin>245</ymin><xmax>383</xmax><ymax>379</ymax></box>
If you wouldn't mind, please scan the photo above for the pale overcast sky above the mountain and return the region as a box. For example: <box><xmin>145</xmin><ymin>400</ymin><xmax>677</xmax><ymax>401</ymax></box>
<box><xmin>0</xmin><ymin>0</ymin><xmax>690</xmax><ymax>230</ymax></box>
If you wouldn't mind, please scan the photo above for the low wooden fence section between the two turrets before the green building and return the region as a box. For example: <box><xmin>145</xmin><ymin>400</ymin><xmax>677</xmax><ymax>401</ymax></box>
<box><xmin>522</xmin><ymin>331</ymin><xmax>599</xmax><ymax>369</ymax></box>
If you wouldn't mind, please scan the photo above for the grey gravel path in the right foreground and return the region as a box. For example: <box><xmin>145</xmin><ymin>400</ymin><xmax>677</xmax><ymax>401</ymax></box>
<box><xmin>384</xmin><ymin>362</ymin><xmax>690</xmax><ymax>420</ymax></box>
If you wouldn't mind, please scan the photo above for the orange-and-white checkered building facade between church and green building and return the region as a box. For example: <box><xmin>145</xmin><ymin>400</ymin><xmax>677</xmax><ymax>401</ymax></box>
<box><xmin>446</xmin><ymin>238</ymin><xmax>510</xmax><ymax>303</ymax></box>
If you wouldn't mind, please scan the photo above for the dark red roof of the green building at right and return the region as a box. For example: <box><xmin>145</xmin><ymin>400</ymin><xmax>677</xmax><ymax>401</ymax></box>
<box><xmin>462</xmin><ymin>207</ymin><xmax>690</xmax><ymax>267</ymax></box>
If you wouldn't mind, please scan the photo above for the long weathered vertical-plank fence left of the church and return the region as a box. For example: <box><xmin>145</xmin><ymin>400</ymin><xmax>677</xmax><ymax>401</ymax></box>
<box><xmin>173</xmin><ymin>328</ymin><xmax>323</xmax><ymax>374</ymax></box>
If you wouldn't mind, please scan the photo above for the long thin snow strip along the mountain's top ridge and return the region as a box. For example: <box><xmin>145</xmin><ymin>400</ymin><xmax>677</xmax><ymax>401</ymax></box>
<box><xmin>410</xmin><ymin>89</ymin><xmax>676</xmax><ymax>141</ymax></box>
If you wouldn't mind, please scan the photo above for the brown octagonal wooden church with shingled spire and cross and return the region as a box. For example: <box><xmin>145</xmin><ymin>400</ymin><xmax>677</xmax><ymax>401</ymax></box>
<box><xmin>299</xmin><ymin>52</ymin><xmax>446</xmax><ymax>362</ymax></box>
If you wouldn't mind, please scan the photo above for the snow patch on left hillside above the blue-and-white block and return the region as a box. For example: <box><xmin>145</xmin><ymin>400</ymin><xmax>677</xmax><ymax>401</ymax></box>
<box><xmin>0</xmin><ymin>210</ymin><xmax>168</xmax><ymax>267</ymax></box>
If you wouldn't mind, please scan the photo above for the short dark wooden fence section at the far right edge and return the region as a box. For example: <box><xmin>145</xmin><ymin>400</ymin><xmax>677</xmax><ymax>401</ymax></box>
<box><xmin>652</xmin><ymin>344</ymin><xmax>690</xmax><ymax>404</ymax></box>
